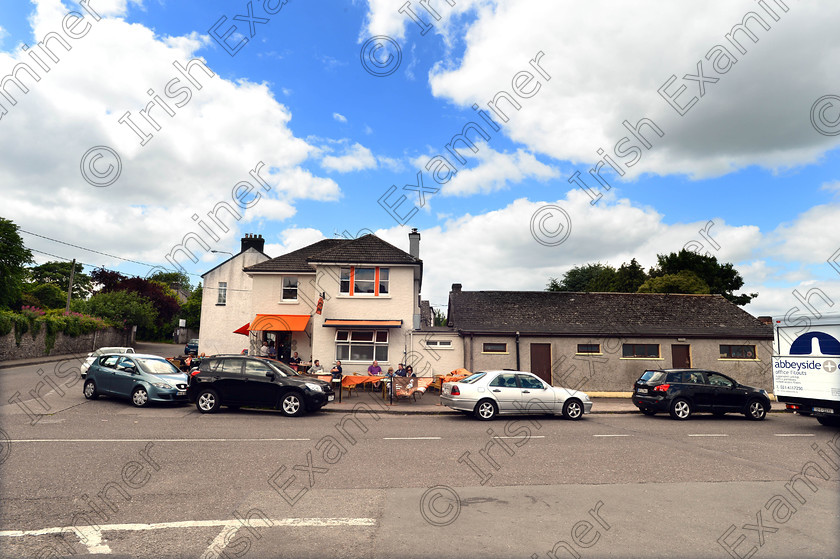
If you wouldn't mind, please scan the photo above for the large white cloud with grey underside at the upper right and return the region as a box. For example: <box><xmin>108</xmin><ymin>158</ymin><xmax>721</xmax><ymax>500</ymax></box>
<box><xmin>412</xmin><ymin>0</ymin><xmax>840</xmax><ymax>178</ymax></box>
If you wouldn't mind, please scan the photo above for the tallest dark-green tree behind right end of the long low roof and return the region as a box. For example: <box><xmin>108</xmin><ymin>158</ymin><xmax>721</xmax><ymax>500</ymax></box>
<box><xmin>650</xmin><ymin>249</ymin><xmax>758</xmax><ymax>305</ymax></box>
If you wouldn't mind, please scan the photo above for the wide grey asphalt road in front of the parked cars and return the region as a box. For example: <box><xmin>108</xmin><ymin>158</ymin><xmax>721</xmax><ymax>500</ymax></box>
<box><xmin>0</xmin><ymin>346</ymin><xmax>840</xmax><ymax>558</ymax></box>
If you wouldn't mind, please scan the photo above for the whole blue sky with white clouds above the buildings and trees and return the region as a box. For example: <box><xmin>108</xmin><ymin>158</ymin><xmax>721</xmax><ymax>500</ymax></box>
<box><xmin>0</xmin><ymin>0</ymin><xmax>840</xmax><ymax>317</ymax></box>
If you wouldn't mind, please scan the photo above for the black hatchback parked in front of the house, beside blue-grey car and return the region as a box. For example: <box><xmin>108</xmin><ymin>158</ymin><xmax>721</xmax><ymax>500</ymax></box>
<box><xmin>187</xmin><ymin>355</ymin><xmax>335</xmax><ymax>415</ymax></box>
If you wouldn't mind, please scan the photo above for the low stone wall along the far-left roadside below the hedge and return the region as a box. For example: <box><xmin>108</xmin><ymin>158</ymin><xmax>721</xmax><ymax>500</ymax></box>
<box><xmin>0</xmin><ymin>325</ymin><xmax>133</xmax><ymax>361</ymax></box>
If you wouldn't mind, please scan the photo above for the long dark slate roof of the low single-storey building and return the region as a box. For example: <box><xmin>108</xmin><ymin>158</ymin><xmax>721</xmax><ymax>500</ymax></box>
<box><xmin>448</xmin><ymin>291</ymin><xmax>773</xmax><ymax>339</ymax></box>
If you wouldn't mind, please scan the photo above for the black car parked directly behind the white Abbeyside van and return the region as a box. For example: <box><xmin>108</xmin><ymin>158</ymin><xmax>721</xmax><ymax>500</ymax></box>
<box><xmin>633</xmin><ymin>369</ymin><xmax>770</xmax><ymax>421</ymax></box>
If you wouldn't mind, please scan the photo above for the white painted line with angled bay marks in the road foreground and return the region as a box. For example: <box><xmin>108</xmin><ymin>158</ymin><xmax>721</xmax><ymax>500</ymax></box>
<box><xmin>0</xmin><ymin>518</ymin><xmax>376</xmax><ymax>554</ymax></box>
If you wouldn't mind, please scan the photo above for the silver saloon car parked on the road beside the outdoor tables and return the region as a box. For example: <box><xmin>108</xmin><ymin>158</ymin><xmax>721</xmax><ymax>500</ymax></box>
<box><xmin>440</xmin><ymin>371</ymin><xmax>592</xmax><ymax>420</ymax></box>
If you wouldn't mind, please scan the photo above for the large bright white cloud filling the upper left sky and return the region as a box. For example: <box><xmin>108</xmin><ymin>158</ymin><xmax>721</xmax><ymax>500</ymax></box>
<box><xmin>0</xmin><ymin>0</ymin><xmax>341</xmax><ymax>272</ymax></box>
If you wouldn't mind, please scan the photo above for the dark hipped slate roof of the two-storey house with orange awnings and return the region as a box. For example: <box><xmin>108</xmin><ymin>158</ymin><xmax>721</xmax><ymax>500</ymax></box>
<box><xmin>245</xmin><ymin>234</ymin><xmax>421</xmax><ymax>273</ymax></box>
